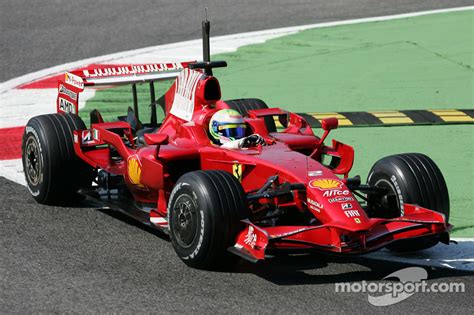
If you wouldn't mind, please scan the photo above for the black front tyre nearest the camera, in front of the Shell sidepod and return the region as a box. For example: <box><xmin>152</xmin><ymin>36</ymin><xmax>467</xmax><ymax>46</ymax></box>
<box><xmin>168</xmin><ymin>170</ymin><xmax>249</xmax><ymax>269</ymax></box>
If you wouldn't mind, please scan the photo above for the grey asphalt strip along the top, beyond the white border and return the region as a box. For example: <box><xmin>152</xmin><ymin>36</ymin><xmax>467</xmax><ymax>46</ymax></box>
<box><xmin>0</xmin><ymin>0</ymin><xmax>474</xmax><ymax>82</ymax></box>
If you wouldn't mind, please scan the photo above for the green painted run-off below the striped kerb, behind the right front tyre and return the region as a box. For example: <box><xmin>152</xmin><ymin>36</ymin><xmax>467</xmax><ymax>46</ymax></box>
<box><xmin>328</xmin><ymin>125</ymin><xmax>474</xmax><ymax>237</ymax></box>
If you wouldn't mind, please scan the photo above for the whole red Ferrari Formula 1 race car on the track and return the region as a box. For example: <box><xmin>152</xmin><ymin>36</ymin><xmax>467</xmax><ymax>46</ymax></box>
<box><xmin>22</xmin><ymin>21</ymin><xmax>451</xmax><ymax>268</ymax></box>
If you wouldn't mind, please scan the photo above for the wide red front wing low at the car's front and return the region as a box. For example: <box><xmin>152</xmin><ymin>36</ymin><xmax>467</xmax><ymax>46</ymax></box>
<box><xmin>229</xmin><ymin>204</ymin><xmax>452</xmax><ymax>262</ymax></box>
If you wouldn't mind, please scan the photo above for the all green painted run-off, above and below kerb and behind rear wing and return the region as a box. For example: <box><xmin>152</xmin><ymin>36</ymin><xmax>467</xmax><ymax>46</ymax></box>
<box><xmin>82</xmin><ymin>10</ymin><xmax>474</xmax><ymax>237</ymax></box>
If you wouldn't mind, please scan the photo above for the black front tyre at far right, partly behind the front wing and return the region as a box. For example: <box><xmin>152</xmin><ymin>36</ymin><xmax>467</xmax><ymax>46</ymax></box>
<box><xmin>367</xmin><ymin>153</ymin><xmax>449</xmax><ymax>252</ymax></box>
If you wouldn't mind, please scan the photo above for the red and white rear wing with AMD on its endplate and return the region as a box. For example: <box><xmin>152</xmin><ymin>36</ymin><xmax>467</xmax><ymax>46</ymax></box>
<box><xmin>56</xmin><ymin>62</ymin><xmax>192</xmax><ymax>114</ymax></box>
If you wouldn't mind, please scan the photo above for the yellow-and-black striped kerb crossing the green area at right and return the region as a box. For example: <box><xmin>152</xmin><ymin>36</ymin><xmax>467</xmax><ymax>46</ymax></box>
<box><xmin>290</xmin><ymin>109</ymin><xmax>474</xmax><ymax>128</ymax></box>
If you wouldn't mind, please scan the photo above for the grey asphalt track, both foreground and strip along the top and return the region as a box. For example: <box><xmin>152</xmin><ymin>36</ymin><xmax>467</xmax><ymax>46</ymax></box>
<box><xmin>0</xmin><ymin>0</ymin><xmax>474</xmax><ymax>313</ymax></box>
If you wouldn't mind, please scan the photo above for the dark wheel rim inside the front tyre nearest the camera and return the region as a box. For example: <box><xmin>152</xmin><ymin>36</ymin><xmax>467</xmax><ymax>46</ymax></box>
<box><xmin>171</xmin><ymin>194</ymin><xmax>198</xmax><ymax>248</ymax></box>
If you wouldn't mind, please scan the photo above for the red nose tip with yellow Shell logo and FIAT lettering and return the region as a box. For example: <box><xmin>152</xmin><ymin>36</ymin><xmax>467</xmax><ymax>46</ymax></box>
<box><xmin>307</xmin><ymin>176</ymin><xmax>370</xmax><ymax>230</ymax></box>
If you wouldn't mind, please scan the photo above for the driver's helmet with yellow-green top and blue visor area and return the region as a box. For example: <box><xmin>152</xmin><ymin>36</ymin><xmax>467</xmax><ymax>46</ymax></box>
<box><xmin>209</xmin><ymin>109</ymin><xmax>246</xmax><ymax>144</ymax></box>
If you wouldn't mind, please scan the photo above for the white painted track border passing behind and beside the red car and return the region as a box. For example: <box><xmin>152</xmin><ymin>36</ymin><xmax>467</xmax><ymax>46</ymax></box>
<box><xmin>0</xmin><ymin>6</ymin><xmax>474</xmax><ymax>271</ymax></box>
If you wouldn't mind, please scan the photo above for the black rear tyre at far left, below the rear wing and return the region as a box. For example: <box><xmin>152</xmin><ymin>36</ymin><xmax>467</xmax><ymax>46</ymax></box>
<box><xmin>22</xmin><ymin>114</ymin><xmax>94</xmax><ymax>205</ymax></box>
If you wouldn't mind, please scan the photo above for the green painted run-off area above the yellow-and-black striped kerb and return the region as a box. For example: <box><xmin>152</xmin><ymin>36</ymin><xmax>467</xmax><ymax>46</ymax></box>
<box><xmin>214</xmin><ymin>10</ymin><xmax>474</xmax><ymax>112</ymax></box>
